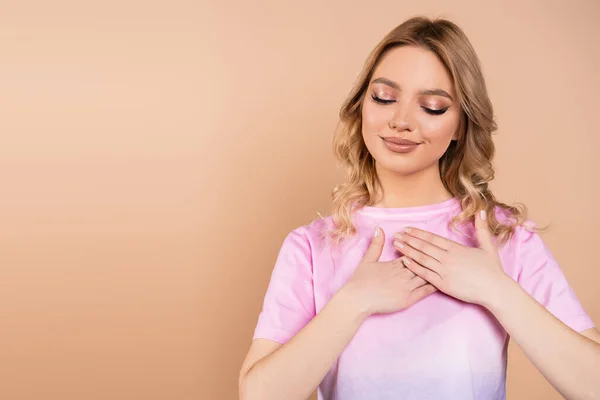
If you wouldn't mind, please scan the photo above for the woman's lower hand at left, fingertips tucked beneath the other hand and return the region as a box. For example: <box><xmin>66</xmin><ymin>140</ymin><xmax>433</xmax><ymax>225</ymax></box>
<box><xmin>342</xmin><ymin>227</ymin><xmax>437</xmax><ymax>315</ymax></box>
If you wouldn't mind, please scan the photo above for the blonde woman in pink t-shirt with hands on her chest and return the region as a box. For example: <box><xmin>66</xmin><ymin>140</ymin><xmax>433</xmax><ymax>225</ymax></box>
<box><xmin>240</xmin><ymin>18</ymin><xmax>600</xmax><ymax>400</ymax></box>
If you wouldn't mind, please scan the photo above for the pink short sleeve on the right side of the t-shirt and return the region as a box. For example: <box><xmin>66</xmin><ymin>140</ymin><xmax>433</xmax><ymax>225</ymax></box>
<box><xmin>517</xmin><ymin>228</ymin><xmax>594</xmax><ymax>332</ymax></box>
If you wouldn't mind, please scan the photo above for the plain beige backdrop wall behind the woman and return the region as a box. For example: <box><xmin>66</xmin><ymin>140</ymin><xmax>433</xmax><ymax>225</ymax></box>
<box><xmin>0</xmin><ymin>0</ymin><xmax>600</xmax><ymax>400</ymax></box>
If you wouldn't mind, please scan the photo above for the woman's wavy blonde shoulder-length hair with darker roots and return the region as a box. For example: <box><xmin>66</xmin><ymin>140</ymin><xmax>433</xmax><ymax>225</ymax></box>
<box><xmin>327</xmin><ymin>16</ymin><xmax>538</xmax><ymax>245</ymax></box>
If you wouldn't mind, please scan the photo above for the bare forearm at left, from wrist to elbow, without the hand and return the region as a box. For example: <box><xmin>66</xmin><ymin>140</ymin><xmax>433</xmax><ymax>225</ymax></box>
<box><xmin>243</xmin><ymin>289</ymin><xmax>367</xmax><ymax>400</ymax></box>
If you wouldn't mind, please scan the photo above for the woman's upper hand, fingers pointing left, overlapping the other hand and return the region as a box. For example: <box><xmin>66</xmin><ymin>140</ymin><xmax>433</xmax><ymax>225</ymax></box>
<box><xmin>394</xmin><ymin>212</ymin><xmax>510</xmax><ymax>306</ymax></box>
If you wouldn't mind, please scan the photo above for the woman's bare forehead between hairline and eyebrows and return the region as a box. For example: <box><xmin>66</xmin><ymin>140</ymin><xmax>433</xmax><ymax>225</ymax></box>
<box><xmin>372</xmin><ymin>46</ymin><xmax>454</xmax><ymax>94</ymax></box>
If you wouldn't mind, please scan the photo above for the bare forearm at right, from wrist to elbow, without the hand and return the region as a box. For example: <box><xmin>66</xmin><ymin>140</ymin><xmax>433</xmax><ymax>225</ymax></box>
<box><xmin>485</xmin><ymin>277</ymin><xmax>600</xmax><ymax>400</ymax></box>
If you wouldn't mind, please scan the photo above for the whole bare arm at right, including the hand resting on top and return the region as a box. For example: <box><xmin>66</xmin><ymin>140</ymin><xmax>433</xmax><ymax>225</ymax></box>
<box><xmin>396</xmin><ymin>213</ymin><xmax>600</xmax><ymax>400</ymax></box>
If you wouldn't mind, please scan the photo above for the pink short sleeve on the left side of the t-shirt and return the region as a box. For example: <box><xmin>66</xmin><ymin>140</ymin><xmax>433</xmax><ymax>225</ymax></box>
<box><xmin>254</xmin><ymin>228</ymin><xmax>315</xmax><ymax>344</ymax></box>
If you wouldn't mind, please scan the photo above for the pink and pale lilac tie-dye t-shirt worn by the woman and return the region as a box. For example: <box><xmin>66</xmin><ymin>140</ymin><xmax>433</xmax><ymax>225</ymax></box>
<box><xmin>254</xmin><ymin>199</ymin><xmax>594</xmax><ymax>400</ymax></box>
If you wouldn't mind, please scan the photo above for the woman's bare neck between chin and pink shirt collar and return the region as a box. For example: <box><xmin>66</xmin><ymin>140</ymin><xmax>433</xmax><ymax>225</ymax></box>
<box><xmin>373</xmin><ymin>165</ymin><xmax>453</xmax><ymax>208</ymax></box>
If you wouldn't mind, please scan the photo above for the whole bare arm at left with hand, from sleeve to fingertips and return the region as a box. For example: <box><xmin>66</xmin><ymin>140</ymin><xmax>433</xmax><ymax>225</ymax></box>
<box><xmin>239</xmin><ymin>231</ymin><xmax>436</xmax><ymax>400</ymax></box>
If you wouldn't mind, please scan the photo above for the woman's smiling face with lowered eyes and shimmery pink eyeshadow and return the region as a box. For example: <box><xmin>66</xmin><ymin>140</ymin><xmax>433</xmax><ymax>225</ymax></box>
<box><xmin>362</xmin><ymin>46</ymin><xmax>460</xmax><ymax>175</ymax></box>
